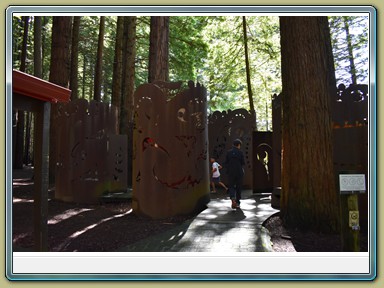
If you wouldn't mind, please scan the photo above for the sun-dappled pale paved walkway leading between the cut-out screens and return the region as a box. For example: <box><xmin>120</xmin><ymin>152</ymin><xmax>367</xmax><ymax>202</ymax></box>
<box><xmin>118</xmin><ymin>190</ymin><xmax>278</xmax><ymax>252</ymax></box>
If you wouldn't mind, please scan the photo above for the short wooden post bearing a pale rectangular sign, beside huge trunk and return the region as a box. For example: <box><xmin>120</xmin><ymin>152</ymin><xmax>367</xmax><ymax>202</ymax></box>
<box><xmin>339</xmin><ymin>174</ymin><xmax>366</xmax><ymax>252</ymax></box>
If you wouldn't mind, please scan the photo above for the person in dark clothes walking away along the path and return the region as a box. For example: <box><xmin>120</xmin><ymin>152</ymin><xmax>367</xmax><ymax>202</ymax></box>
<box><xmin>223</xmin><ymin>139</ymin><xmax>245</xmax><ymax>209</ymax></box>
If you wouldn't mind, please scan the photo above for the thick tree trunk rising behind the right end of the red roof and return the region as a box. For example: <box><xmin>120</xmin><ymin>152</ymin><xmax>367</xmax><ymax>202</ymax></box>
<box><xmin>49</xmin><ymin>16</ymin><xmax>72</xmax><ymax>183</ymax></box>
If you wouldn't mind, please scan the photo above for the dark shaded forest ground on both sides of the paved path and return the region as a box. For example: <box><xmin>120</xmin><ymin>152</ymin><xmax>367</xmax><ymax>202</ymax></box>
<box><xmin>12</xmin><ymin>169</ymin><xmax>368</xmax><ymax>252</ymax></box>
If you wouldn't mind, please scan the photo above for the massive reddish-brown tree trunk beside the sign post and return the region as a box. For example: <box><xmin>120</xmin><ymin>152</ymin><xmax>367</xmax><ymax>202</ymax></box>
<box><xmin>280</xmin><ymin>16</ymin><xmax>340</xmax><ymax>231</ymax></box>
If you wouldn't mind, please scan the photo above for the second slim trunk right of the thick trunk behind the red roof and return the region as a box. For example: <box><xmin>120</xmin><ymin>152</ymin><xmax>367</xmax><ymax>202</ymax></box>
<box><xmin>93</xmin><ymin>16</ymin><xmax>105</xmax><ymax>101</ymax></box>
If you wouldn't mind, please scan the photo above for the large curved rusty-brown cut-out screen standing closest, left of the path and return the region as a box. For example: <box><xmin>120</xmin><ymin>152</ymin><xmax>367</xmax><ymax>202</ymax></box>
<box><xmin>132</xmin><ymin>82</ymin><xmax>209</xmax><ymax>218</ymax></box>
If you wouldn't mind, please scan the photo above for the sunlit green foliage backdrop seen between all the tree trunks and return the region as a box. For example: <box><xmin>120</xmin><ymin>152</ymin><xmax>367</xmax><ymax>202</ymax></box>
<box><xmin>12</xmin><ymin>16</ymin><xmax>368</xmax><ymax>130</ymax></box>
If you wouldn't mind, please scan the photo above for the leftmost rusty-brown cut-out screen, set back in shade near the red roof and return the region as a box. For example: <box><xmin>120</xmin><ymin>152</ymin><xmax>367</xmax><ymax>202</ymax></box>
<box><xmin>55</xmin><ymin>99</ymin><xmax>127</xmax><ymax>203</ymax></box>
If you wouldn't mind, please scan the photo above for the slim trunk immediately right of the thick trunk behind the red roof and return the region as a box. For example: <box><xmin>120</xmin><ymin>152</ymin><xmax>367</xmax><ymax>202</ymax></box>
<box><xmin>69</xmin><ymin>16</ymin><xmax>81</xmax><ymax>100</ymax></box>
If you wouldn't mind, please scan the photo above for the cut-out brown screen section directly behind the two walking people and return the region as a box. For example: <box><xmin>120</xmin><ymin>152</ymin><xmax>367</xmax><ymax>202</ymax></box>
<box><xmin>208</xmin><ymin>109</ymin><xmax>273</xmax><ymax>193</ymax></box>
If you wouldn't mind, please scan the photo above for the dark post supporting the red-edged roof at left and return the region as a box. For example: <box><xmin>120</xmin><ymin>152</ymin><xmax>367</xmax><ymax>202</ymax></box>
<box><xmin>12</xmin><ymin>70</ymin><xmax>71</xmax><ymax>251</ymax></box>
